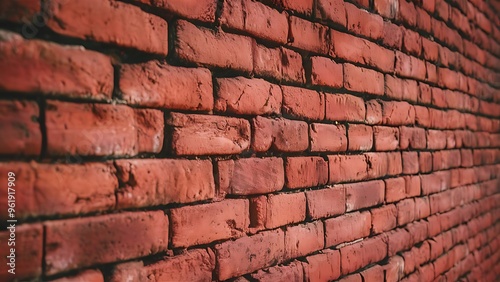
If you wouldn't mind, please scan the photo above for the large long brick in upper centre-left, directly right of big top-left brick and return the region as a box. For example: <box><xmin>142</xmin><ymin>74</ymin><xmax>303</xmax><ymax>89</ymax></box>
<box><xmin>175</xmin><ymin>20</ymin><xmax>253</xmax><ymax>72</ymax></box>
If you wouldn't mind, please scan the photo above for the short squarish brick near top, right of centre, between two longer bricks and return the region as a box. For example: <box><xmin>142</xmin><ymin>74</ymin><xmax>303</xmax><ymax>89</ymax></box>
<box><xmin>288</xmin><ymin>16</ymin><xmax>328</xmax><ymax>54</ymax></box>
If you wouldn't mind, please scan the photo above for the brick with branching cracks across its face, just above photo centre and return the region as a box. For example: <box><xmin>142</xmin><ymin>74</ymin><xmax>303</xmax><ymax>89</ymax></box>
<box><xmin>215</xmin><ymin>77</ymin><xmax>282</xmax><ymax>115</ymax></box>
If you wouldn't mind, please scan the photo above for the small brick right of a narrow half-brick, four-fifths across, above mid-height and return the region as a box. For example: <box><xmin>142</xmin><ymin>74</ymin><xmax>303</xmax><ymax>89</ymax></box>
<box><xmin>380</xmin><ymin>101</ymin><xmax>415</xmax><ymax>125</ymax></box>
